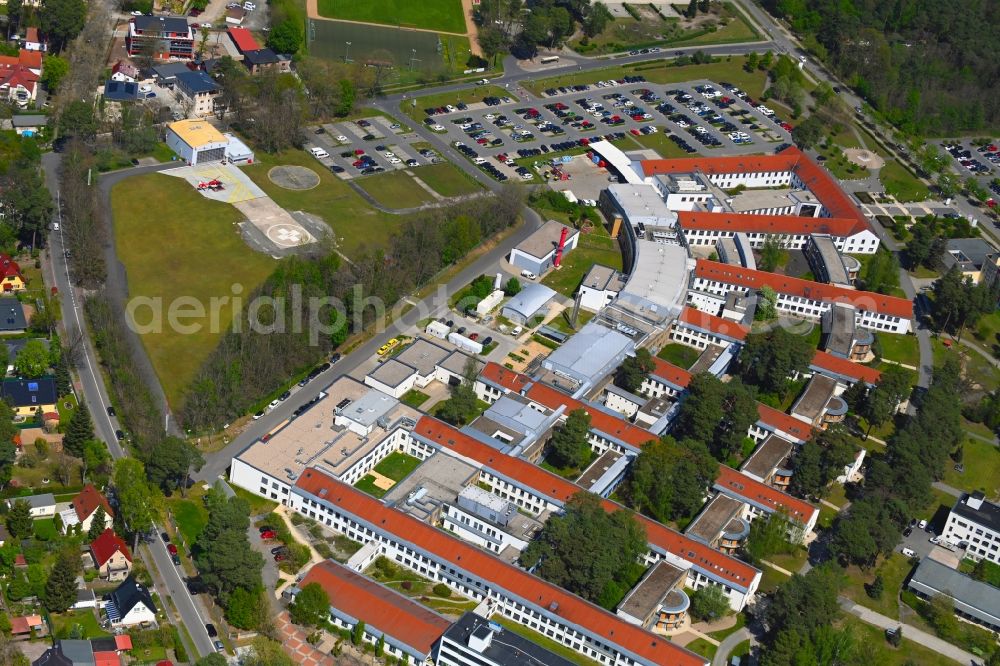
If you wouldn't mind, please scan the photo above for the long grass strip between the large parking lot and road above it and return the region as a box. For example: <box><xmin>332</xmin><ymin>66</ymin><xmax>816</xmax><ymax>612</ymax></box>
<box><xmin>524</xmin><ymin>56</ymin><xmax>767</xmax><ymax>97</ymax></box>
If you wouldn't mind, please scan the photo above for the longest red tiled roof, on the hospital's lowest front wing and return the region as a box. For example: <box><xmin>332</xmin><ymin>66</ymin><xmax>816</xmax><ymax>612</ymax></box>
<box><xmin>295</xmin><ymin>468</ymin><xmax>705</xmax><ymax>666</ymax></box>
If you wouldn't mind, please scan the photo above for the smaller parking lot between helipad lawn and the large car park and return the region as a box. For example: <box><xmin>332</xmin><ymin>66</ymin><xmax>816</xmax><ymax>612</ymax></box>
<box><xmin>305</xmin><ymin>116</ymin><xmax>441</xmax><ymax>180</ymax></box>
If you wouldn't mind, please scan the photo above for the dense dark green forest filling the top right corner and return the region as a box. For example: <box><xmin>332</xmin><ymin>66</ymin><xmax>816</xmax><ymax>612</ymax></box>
<box><xmin>761</xmin><ymin>0</ymin><xmax>1000</xmax><ymax>136</ymax></box>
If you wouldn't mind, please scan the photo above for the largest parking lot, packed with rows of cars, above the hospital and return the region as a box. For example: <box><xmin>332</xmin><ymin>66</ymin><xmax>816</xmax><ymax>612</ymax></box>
<box><xmin>410</xmin><ymin>76</ymin><xmax>792</xmax><ymax>181</ymax></box>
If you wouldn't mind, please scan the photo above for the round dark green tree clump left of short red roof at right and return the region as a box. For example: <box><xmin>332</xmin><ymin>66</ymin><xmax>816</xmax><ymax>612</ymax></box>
<box><xmin>737</xmin><ymin>326</ymin><xmax>815</xmax><ymax>395</ymax></box>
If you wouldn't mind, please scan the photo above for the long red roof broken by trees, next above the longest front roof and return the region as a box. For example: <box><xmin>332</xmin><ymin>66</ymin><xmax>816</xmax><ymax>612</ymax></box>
<box><xmin>413</xmin><ymin>416</ymin><xmax>756</xmax><ymax>588</ymax></box>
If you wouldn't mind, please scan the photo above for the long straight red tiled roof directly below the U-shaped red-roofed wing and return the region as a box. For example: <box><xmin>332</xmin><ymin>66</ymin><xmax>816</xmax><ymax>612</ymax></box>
<box><xmin>694</xmin><ymin>259</ymin><xmax>913</xmax><ymax>319</ymax></box>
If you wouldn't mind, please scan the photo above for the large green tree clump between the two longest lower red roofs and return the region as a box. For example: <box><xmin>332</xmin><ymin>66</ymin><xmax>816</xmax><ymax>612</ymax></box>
<box><xmin>520</xmin><ymin>492</ymin><xmax>647</xmax><ymax>603</ymax></box>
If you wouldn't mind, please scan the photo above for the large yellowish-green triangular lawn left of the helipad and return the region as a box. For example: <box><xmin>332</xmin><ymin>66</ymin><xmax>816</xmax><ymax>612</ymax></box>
<box><xmin>111</xmin><ymin>174</ymin><xmax>276</xmax><ymax>408</ymax></box>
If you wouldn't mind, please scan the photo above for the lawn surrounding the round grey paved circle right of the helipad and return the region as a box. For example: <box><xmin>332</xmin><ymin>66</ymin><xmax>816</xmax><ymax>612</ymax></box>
<box><xmin>242</xmin><ymin>150</ymin><xmax>406</xmax><ymax>256</ymax></box>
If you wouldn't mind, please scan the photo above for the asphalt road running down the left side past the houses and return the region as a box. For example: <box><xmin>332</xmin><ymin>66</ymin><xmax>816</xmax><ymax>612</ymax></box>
<box><xmin>42</xmin><ymin>153</ymin><xmax>215</xmax><ymax>656</ymax></box>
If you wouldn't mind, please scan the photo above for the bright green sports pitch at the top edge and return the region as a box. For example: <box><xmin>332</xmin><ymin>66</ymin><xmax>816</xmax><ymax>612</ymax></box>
<box><xmin>319</xmin><ymin>0</ymin><xmax>465</xmax><ymax>34</ymax></box>
